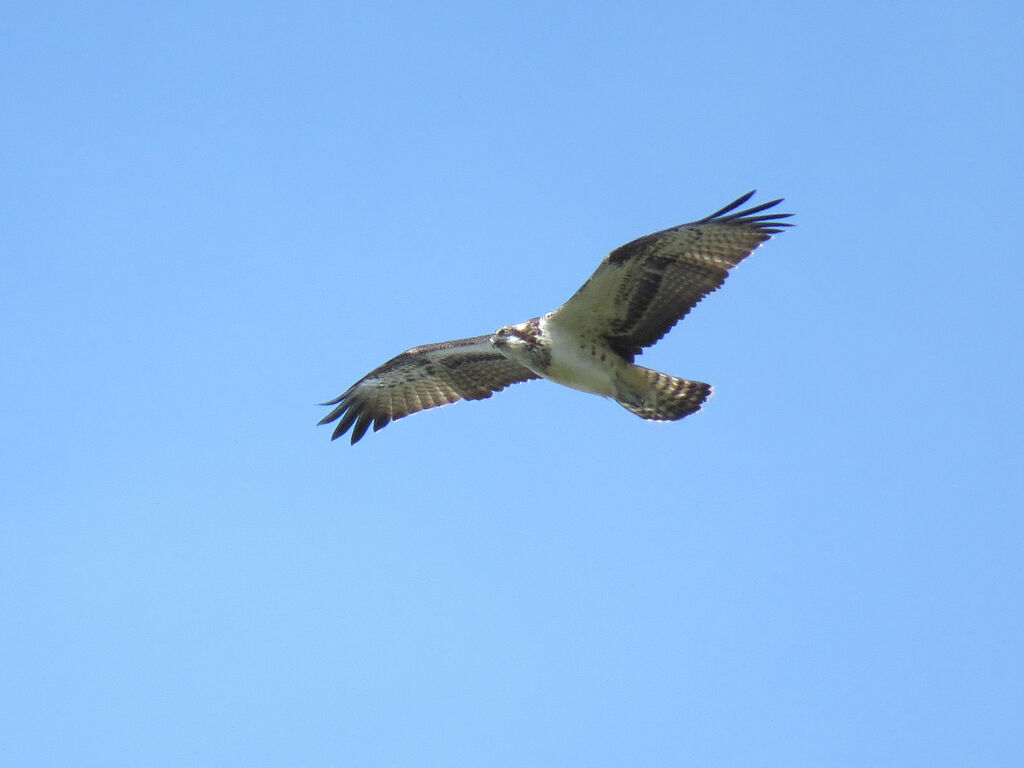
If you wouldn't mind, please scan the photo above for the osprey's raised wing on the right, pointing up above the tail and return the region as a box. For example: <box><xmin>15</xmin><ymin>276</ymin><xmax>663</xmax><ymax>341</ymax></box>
<box><xmin>550</xmin><ymin>191</ymin><xmax>793</xmax><ymax>360</ymax></box>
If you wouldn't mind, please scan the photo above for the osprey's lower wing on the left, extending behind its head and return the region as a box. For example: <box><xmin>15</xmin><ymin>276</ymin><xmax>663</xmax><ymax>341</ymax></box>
<box><xmin>317</xmin><ymin>336</ymin><xmax>538</xmax><ymax>445</ymax></box>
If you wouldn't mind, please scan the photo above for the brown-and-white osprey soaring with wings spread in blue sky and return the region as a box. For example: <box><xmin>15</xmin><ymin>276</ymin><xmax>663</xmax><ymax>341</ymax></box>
<box><xmin>318</xmin><ymin>191</ymin><xmax>793</xmax><ymax>444</ymax></box>
